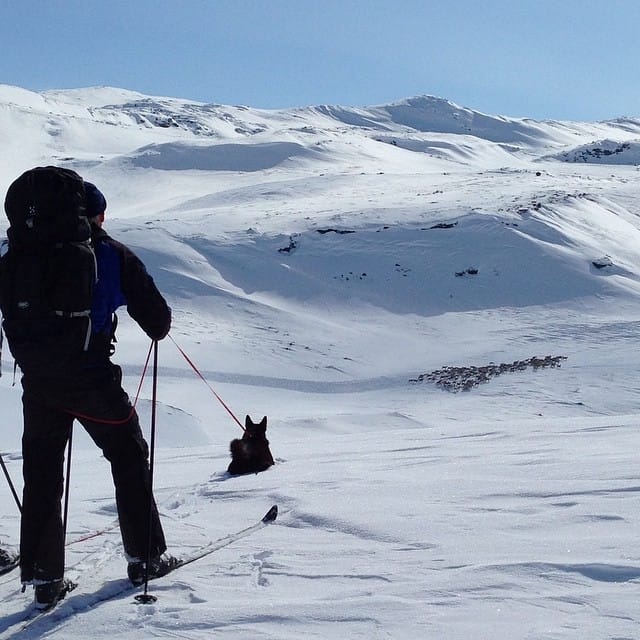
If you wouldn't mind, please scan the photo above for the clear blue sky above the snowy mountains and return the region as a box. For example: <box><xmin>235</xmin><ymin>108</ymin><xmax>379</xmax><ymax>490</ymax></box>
<box><xmin>0</xmin><ymin>0</ymin><xmax>640</xmax><ymax>120</ymax></box>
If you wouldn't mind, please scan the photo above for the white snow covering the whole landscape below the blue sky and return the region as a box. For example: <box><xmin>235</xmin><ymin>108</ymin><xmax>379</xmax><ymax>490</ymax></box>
<box><xmin>0</xmin><ymin>85</ymin><xmax>640</xmax><ymax>640</ymax></box>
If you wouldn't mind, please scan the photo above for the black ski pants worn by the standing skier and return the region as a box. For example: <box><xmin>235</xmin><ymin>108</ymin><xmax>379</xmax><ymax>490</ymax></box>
<box><xmin>20</xmin><ymin>362</ymin><xmax>166</xmax><ymax>582</ymax></box>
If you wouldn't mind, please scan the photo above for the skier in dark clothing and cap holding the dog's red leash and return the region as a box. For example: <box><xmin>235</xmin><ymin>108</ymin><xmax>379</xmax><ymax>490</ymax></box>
<box><xmin>5</xmin><ymin>176</ymin><xmax>177</xmax><ymax>609</ymax></box>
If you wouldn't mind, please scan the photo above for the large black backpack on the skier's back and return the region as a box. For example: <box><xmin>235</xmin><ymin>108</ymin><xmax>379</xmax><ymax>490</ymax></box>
<box><xmin>0</xmin><ymin>167</ymin><xmax>96</xmax><ymax>376</ymax></box>
